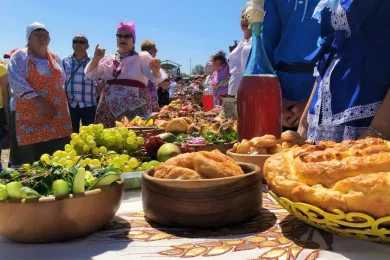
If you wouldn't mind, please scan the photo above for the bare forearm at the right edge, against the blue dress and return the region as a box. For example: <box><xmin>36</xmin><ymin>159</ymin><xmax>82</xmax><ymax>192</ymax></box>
<box><xmin>362</xmin><ymin>89</ymin><xmax>390</xmax><ymax>139</ymax></box>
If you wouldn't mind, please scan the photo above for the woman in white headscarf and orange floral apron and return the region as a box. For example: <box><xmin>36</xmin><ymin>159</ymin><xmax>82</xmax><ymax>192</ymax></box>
<box><xmin>8</xmin><ymin>22</ymin><xmax>72</xmax><ymax>165</ymax></box>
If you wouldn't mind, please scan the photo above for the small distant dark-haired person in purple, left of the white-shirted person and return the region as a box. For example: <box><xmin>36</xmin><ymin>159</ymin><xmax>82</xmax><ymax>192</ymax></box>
<box><xmin>211</xmin><ymin>51</ymin><xmax>230</xmax><ymax>106</ymax></box>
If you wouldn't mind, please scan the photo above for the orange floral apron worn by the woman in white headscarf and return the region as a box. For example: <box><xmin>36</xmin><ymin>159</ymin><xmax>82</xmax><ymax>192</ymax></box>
<box><xmin>15</xmin><ymin>53</ymin><xmax>72</xmax><ymax>146</ymax></box>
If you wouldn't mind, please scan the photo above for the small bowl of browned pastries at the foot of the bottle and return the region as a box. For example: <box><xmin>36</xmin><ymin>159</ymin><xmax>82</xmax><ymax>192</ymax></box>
<box><xmin>227</xmin><ymin>131</ymin><xmax>311</xmax><ymax>172</ymax></box>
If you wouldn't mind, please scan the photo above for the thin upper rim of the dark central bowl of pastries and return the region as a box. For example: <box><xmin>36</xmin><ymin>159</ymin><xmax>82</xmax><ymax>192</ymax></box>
<box><xmin>142</xmin><ymin>162</ymin><xmax>261</xmax><ymax>184</ymax></box>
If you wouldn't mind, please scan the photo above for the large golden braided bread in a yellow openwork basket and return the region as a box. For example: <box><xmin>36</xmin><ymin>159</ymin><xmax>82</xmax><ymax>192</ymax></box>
<box><xmin>264</xmin><ymin>138</ymin><xmax>390</xmax><ymax>242</ymax></box>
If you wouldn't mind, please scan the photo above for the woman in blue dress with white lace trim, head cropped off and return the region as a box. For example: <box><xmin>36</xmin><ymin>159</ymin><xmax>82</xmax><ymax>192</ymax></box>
<box><xmin>299</xmin><ymin>0</ymin><xmax>390</xmax><ymax>142</ymax></box>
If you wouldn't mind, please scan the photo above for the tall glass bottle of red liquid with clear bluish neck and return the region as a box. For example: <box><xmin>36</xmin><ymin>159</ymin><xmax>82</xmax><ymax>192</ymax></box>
<box><xmin>237</xmin><ymin>23</ymin><xmax>282</xmax><ymax>141</ymax></box>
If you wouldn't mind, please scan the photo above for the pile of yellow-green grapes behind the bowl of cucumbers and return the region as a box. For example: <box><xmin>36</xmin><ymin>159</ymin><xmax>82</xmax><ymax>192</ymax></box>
<box><xmin>40</xmin><ymin>124</ymin><xmax>160</xmax><ymax>172</ymax></box>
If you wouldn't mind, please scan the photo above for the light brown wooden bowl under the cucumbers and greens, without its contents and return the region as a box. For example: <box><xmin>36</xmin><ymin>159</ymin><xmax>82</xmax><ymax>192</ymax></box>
<box><xmin>0</xmin><ymin>179</ymin><xmax>123</xmax><ymax>243</ymax></box>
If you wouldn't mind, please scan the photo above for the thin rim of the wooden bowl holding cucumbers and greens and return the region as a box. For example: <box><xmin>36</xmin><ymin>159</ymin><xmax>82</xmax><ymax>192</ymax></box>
<box><xmin>0</xmin><ymin>176</ymin><xmax>124</xmax><ymax>204</ymax></box>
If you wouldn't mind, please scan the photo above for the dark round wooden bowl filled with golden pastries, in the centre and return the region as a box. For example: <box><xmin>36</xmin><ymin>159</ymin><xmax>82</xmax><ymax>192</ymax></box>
<box><xmin>142</xmin><ymin>150</ymin><xmax>262</xmax><ymax>228</ymax></box>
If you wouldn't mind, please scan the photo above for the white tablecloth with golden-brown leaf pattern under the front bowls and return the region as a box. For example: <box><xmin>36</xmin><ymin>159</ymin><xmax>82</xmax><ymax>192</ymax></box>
<box><xmin>0</xmin><ymin>186</ymin><xmax>390</xmax><ymax>260</ymax></box>
